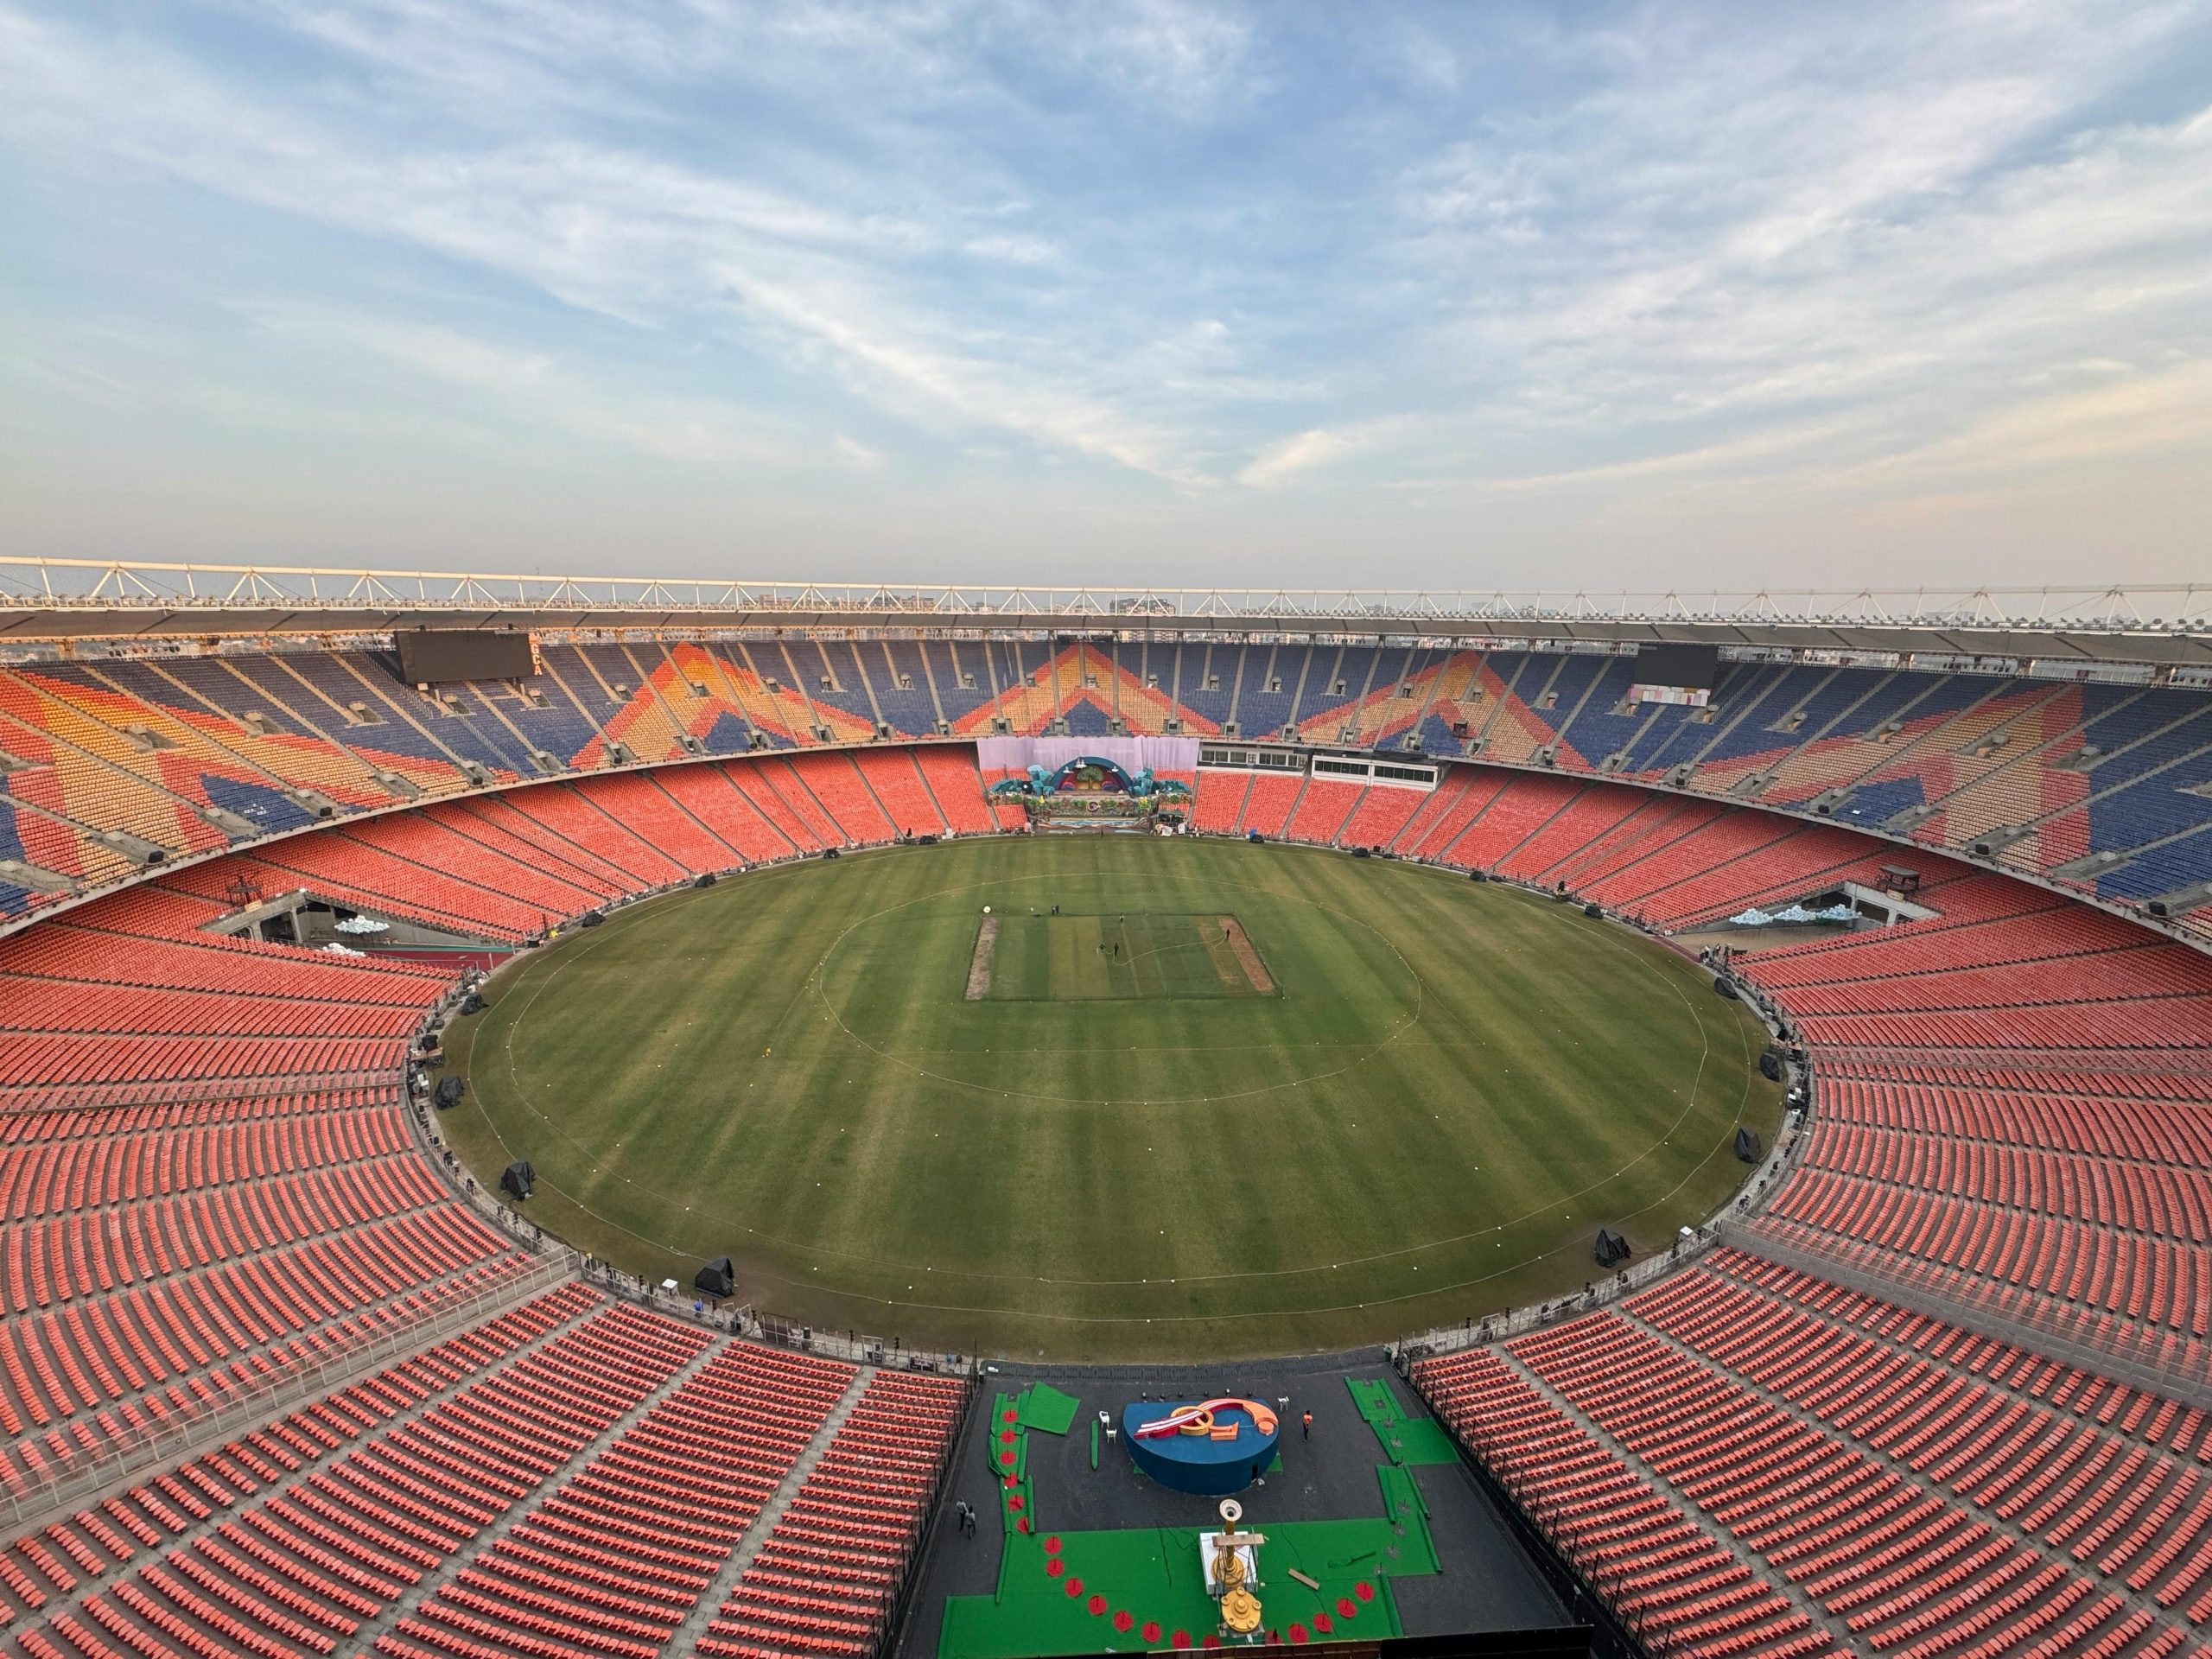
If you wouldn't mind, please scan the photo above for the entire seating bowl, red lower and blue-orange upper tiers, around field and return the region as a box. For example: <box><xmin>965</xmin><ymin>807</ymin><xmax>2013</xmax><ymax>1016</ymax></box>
<box><xmin>0</xmin><ymin>617</ymin><xmax>2212</xmax><ymax>1659</ymax></box>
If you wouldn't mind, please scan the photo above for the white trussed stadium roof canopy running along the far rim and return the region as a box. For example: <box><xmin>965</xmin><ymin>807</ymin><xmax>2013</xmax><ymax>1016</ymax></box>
<box><xmin>0</xmin><ymin>557</ymin><xmax>2212</xmax><ymax>666</ymax></box>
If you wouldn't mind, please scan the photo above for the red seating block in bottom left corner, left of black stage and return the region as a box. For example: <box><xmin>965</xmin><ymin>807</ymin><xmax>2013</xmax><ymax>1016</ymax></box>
<box><xmin>0</xmin><ymin>1283</ymin><xmax>967</xmax><ymax>1659</ymax></box>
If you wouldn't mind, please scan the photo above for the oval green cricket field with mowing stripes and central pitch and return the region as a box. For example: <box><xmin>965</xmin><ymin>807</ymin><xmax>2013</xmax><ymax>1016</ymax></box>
<box><xmin>445</xmin><ymin>836</ymin><xmax>1781</xmax><ymax>1358</ymax></box>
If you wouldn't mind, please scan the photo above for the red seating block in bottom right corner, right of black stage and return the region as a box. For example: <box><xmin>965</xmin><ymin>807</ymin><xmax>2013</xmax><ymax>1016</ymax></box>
<box><xmin>1415</xmin><ymin>1252</ymin><xmax>2212</xmax><ymax>1655</ymax></box>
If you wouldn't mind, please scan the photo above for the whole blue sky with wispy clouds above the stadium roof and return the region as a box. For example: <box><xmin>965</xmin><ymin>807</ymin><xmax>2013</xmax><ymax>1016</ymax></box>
<box><xmin>0</xmin><ymin>0</ymin><xmax>2212</xmax><ymax>591</ymax></box>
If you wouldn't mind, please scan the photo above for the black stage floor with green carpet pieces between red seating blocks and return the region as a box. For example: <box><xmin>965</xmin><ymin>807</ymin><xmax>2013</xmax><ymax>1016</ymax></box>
<box><xmin>893</xmin><ymin>1351</ymin><xmax>1586</xmax><ymax>1659</ymax></box>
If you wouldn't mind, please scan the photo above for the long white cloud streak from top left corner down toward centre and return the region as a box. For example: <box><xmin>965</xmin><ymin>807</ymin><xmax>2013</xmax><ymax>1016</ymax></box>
<box><xmin>0</xmin><ymin>6</ymin><xmax>1197</xmax><ymax>482</ymax></box>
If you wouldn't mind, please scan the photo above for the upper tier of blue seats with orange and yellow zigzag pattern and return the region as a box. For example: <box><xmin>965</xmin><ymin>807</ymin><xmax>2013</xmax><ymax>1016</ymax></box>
<box><xmin>0</xmin><ymin>639</ymin><xmax>2212</xmax><ymax>929</ymax></box>
